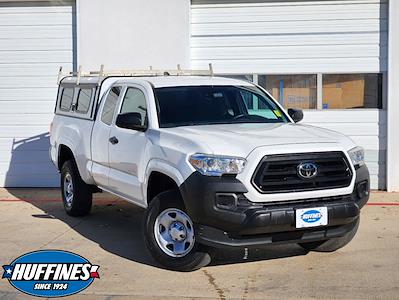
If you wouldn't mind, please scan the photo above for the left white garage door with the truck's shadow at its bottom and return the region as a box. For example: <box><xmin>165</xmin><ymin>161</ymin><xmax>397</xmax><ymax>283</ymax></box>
<box><xmin>0</xmin><ymin>1</ymin><xmax>75</xmax><ymax>187</ymax></box>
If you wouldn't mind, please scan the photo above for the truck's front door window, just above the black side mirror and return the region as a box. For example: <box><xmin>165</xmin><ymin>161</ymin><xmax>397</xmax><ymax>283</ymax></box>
<box><xmin>120</xmin><ymin>88</ymin><xmax>147</xmax><ymax>126</ymax></box>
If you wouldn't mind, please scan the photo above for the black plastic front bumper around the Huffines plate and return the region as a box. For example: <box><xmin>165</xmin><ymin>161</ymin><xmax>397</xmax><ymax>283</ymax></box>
<box><xmin>180</xmin><ymin>166</ymin><xmax>369</xmax><ymax>247</ymax></box>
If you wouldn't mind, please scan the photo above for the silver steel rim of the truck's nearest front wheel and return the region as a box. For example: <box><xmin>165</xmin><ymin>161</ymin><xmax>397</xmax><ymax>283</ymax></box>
<box><xmin>154</xmin><ymin>208</ymin><xmax>195</xmax><ymax>257</ymax></box>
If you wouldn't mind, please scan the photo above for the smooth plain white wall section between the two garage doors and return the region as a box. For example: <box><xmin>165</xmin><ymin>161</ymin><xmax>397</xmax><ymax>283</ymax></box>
<box><xmin>77</xmin><ymin>0</ymin><xmax>190</xmax><ymax>70</ymax></box>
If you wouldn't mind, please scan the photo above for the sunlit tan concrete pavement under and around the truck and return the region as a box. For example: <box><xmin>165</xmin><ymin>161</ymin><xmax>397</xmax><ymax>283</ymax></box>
<box><xmin>0</xmin><ymin>189</ymin><xmax>399</xmax><ymax>300</ymax></box>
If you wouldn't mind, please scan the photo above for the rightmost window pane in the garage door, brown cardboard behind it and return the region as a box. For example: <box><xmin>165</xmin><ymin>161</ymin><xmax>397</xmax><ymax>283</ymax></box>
<box><xmin>323</xmin><ymin>74</ymin><xmax>382</xmax><ymax>109</ymax></box>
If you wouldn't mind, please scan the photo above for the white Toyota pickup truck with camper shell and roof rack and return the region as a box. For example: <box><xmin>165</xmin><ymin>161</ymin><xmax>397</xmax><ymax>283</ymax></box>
<box><xmin>50</xmin><ymin>69</ymin><xmax>369</xmax><ymax>271</ymax></box>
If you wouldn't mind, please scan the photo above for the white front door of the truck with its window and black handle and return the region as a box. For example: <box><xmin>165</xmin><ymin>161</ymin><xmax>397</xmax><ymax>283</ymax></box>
<box><xmin>109</xmin><ymin>86</ymin><xmax>148</xmax><ymax>205</ymax></box>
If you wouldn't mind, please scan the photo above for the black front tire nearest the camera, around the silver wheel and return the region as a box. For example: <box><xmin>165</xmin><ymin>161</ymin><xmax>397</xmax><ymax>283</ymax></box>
<box><xmin>143</xmin><ymin>190</ymin><xmax>211</xmax><ymax>272</ymax></box>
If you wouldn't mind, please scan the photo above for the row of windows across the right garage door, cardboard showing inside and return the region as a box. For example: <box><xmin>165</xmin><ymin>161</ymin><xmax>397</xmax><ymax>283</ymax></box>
<box><xmin>220</xmin><ymin>73</ymin><xmax>382</xmax><ymax>109</ymax></box>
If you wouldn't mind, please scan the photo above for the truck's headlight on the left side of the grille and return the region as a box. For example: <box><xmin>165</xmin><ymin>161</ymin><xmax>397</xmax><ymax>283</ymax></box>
<box><xmin>188</xmin><ymin>153</ymin><xmax>247</xmax><ymax>176</ymax></box>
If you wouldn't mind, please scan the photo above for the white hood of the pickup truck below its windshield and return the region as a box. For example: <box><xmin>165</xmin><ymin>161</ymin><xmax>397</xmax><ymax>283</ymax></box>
<box><xmin>161</xmin><ymin>123</ymin><xmax>356</xmax><ymax>157</ymax></box>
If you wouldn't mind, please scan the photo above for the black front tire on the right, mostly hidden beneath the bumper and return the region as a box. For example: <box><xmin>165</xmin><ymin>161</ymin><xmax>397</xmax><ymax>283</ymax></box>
<box><xmin>298</xmin><ymin>217</ymin><xmax>360</xmax><ymax>252</ymax></box>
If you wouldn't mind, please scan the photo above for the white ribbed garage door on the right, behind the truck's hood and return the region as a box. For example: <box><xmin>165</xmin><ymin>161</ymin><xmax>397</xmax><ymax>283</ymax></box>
<box><xmin>190</xmin><ymin>0</ymin><xmax>388</xmax><ymax>189</ymax></box>
